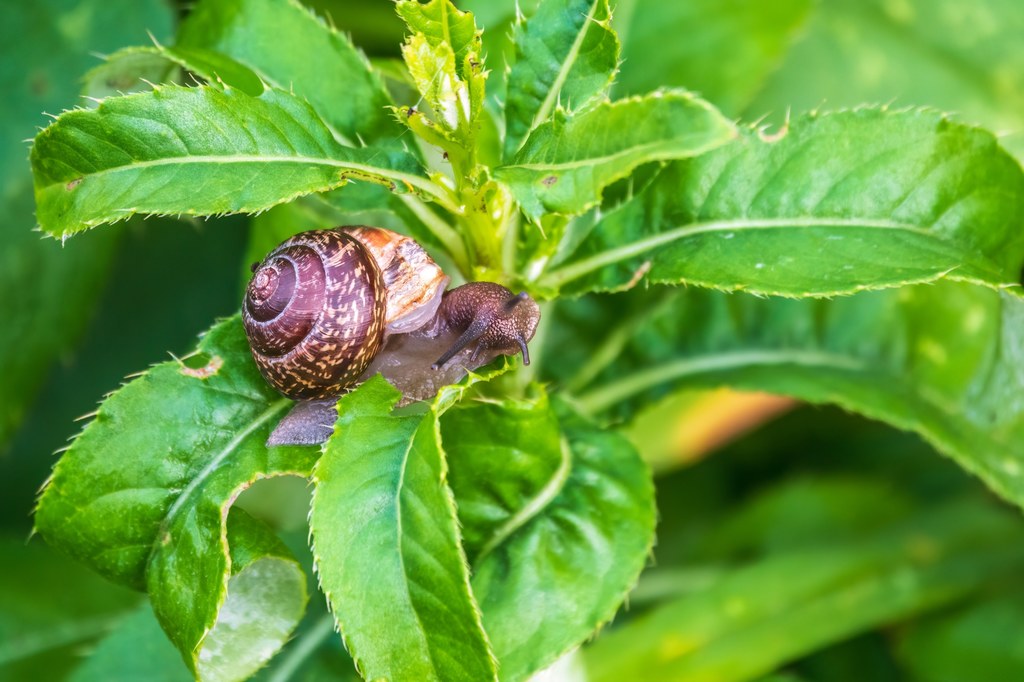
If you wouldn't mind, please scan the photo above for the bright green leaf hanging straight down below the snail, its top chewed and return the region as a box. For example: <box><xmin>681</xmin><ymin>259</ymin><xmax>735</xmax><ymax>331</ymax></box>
<box><xmin>310</xmin><ymin>375</ymin><xmax>497</xmax><ymax>680</ymax></box>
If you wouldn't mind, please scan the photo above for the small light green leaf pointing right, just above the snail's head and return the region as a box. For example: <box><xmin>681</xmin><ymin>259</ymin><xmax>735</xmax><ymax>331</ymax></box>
<box><xmin>495</xmin><ymin>91</ymin><xmax>735</xmax><ymax>221</ymax></box>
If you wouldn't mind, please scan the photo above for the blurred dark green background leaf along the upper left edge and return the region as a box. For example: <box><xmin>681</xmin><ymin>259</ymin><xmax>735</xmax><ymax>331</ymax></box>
<box><xmin>0</xmin><ymin>0</ymin><xmax>172</xmax><ymax>446</ymax></box>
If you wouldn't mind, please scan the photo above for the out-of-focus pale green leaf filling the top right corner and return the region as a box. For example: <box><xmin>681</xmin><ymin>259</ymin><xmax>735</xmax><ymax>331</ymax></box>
<box><xmin>749</xmin><ymin>0</ymin><xmax>1024</xmax><ymax>159</ymax></box>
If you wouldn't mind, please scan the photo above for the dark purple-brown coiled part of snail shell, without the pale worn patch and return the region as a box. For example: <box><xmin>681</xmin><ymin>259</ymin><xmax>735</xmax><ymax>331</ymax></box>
<box><xmin>242</xmin><ymin>229</ymin><xmax>386</xmax><ymax>399</ymax></box>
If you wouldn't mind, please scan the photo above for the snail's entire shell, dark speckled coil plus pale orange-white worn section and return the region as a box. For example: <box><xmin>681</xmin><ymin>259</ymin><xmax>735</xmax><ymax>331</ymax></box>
<box><xmin>242</xmin><ymin>227</ymin><xmax>447</xmax><ymax>399</ymax></box>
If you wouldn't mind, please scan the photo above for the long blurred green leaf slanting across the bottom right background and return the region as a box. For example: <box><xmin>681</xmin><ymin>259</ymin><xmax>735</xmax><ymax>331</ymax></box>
<box><xmin>583</xmin><ymin>503</ymin><xmax>1024</xmax><ymax>682</ymax></box>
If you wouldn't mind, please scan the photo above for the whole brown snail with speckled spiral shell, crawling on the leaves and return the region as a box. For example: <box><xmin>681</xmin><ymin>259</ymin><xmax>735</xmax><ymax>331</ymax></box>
<box><xmin>242</xmin><ymin>225</ymin><xmax>540</xmax><ymax>444</ymax></box>
